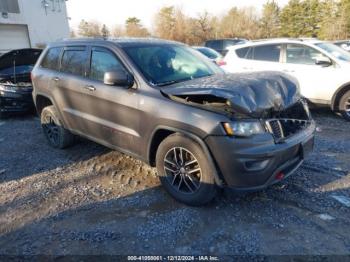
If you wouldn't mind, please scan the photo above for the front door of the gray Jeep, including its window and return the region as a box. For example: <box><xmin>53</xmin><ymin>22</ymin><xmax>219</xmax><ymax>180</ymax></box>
<box><xmin>81</xmin><ymin>46</ymin><xmax>140</xmax><ymax>152</ymax></box>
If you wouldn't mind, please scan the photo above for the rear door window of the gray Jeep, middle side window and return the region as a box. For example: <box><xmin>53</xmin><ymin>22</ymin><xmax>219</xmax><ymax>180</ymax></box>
<box><xmin>61</xmin><ymin>49</ymin><xmax>87</xmax><ymax>76</ymax></box>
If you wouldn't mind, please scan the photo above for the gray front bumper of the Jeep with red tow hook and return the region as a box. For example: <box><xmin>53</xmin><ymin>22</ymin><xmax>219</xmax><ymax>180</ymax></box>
<box><xmin>206</xmin><ymin>120</ymin><xmax>315</xmax><ymax>191</ymax></box>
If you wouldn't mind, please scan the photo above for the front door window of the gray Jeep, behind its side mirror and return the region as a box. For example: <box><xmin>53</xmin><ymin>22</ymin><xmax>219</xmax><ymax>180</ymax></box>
<box><xmin>90</xmin><ymin>50</ymin><xmax>124</xmax><ymax>81</ymax></box>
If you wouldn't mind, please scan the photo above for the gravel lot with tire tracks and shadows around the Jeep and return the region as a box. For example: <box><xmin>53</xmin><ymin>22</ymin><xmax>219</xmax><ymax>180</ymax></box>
<box><xmin>0</xmin><ymin>110</ymin><xmax>350</xmax><ymax>255</ymax></box>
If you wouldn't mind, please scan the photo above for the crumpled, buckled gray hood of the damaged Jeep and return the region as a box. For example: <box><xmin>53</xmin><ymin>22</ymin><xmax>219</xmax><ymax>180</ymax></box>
<box><xmin>161</xmin><ymin>71</ymin><xmax>301</xmax><ymax>117</ymax></box>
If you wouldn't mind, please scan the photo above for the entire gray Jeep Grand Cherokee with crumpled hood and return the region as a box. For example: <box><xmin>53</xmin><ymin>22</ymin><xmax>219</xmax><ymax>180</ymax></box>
<box><xmin>32</xmin><ymin>39</ymin><xmax>315</xmax><ymax>205</ymax></box>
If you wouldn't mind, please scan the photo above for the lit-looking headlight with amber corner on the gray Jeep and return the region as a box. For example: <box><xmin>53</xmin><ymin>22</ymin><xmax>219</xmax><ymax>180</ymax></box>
<box><xmin>223</xmin><ymin>121</ymin><xmax>265</xmax><ymax>137</ymax></box>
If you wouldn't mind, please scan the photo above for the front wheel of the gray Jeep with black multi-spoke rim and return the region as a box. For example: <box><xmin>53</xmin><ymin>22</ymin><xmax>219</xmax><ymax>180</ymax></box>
<box><xmin>156</xmin><ymin>134</ymin><xmax>217</xmax><ymax>206</ymax></box>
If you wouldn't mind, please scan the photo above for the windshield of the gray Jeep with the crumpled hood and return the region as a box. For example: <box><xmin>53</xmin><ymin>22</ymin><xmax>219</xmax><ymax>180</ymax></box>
<box><xmin>124</xmin><ymin>44</ymin><xmax>222</xmax><ymax>86</ymax></box>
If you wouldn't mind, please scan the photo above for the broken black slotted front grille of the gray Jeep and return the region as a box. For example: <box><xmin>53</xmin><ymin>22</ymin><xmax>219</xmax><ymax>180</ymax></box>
<box><xmin>265</xmin><ymin>118</ymin><xmax>311</xmax><ymax>140</ymax></box>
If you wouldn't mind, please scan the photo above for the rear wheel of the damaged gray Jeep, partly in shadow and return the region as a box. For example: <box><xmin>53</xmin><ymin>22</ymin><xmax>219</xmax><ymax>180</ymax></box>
<box><xmin>41</xmin><ymin>106</ymin><xmax>74</xmax><ymax>149</ymax></box>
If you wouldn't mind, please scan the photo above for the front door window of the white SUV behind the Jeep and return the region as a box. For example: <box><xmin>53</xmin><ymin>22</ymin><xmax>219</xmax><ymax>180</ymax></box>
<box><xmin>286</xmin><ymin>44</ymin><xmax>325</xmax><ymax>65</ymax></box>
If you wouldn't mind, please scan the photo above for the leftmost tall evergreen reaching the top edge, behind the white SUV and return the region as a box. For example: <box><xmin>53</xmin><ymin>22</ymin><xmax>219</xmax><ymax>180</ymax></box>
<box><xmin>260</xmin><ymin>0</ymin><xmax>281</xmax><ymax>38</ymax></box>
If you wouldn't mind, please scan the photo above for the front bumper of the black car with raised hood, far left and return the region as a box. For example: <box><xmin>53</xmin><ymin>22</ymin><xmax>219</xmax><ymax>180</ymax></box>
<box><xmin>0</xmin><ymin>89</ymin><xmax>34</xmax><ymax>115</ymax></box>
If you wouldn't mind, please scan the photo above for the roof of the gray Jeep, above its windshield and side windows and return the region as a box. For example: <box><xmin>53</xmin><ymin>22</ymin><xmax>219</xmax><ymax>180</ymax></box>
<box><xmin>52</xmin><ymin>37</ymin><xmax>183</xmax><ymax>47</ymax></box>
